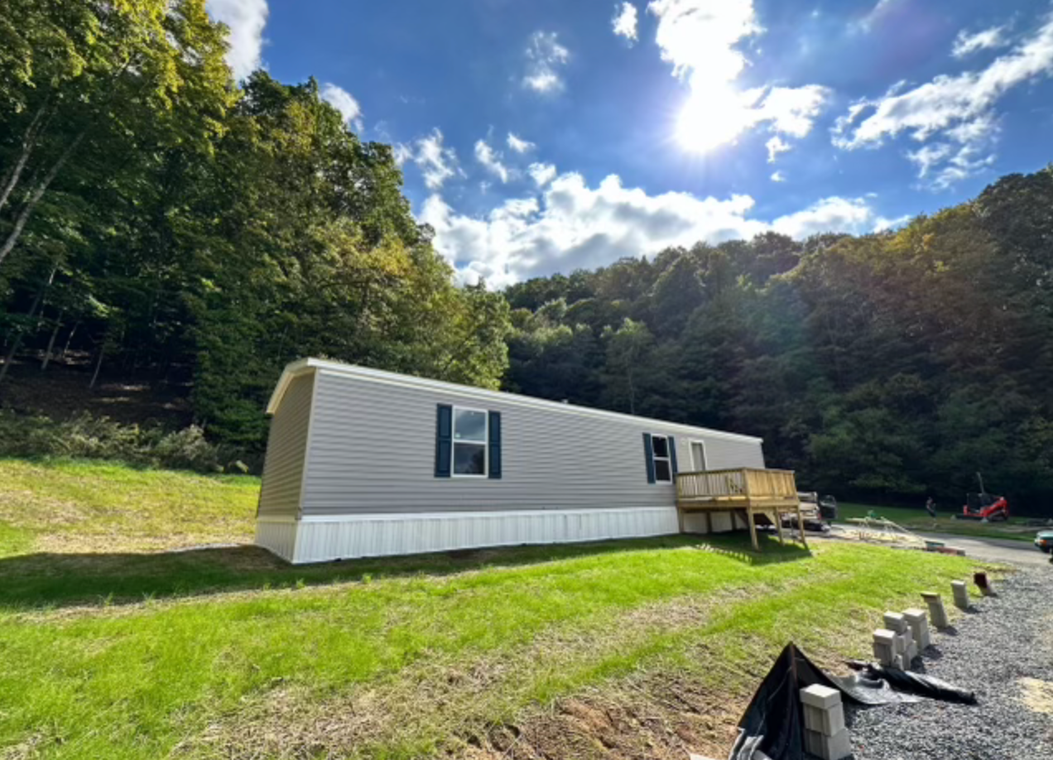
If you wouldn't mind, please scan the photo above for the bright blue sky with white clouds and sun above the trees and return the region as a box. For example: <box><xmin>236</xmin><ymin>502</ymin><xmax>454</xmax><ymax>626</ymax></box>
<box><xmin>208</xmin><ymin>0</ymin><xmax>1053</xmax><ymax>287</ymax></box>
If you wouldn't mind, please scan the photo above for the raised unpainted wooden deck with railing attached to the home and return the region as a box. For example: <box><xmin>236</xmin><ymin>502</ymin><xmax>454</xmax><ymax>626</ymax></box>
<box><xmin>676</xmin><ymin>467</ymin><xmax>808</xmax><ymax>552</ymax></box>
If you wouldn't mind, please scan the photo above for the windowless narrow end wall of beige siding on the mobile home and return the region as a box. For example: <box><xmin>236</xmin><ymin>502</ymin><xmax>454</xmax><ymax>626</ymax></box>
<box><xmin>259</xmin><ymin>373</ymin><xmax>314</xmax><ymax>516</ymax></box>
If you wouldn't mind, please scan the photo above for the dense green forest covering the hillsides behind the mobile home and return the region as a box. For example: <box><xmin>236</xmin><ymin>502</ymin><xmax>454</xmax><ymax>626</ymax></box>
<box><xmin>0</xmin><ymin>0</ymin><xmax>1053</xmax><ymax>513</ymax></box>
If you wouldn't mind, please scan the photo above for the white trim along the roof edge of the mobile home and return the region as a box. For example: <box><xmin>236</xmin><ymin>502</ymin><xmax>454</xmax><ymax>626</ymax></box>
<box><xmin>266</xmin><ymin>359</ymin><xmax>763</xmax><ymax>443</ymax></box>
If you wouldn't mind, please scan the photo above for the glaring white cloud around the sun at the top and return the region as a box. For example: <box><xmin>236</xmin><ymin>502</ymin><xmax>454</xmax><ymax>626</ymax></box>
<box><xmin>648</xmin><ymin>0</ymin><xmax>831</xmax><ymax>152</ymax></box>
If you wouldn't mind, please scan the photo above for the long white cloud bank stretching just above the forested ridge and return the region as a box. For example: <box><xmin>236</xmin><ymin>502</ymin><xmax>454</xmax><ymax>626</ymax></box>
<box><xmin>420</xmin><ymin>173</ymin><xmax>888</xmax><ymax>287</ymax></box>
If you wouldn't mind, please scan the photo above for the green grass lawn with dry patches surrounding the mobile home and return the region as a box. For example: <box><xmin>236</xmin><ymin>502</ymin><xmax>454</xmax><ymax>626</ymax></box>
<box><xmin>0</xmin><ymin>461</ymin><xmax>973</xmax><ymax>760</ymax></box>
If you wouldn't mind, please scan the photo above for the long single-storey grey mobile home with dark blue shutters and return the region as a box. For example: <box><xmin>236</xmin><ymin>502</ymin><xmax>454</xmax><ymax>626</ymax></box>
<box><xmin>256</xmin><ymin>359</ymin><xmax>796</xmax><ymax>563</ymax></box>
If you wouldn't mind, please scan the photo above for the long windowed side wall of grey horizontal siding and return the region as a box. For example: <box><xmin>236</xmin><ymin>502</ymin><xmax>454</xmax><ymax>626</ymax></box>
<box><xmin>301</xmin><ymin>371</ymin><xmax>763</xmax><ymax>516</ymax></box>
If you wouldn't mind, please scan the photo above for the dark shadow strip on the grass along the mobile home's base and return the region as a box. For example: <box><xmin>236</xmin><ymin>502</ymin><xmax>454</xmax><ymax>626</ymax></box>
<box><xmin>0</xmin><ymin>534</ymin><xmax>809</xmax><ymax>612</ymax></box>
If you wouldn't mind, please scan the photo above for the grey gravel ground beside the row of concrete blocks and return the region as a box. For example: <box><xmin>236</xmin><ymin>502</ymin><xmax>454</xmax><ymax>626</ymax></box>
<box><xmin>846</xmin><ymin>567</ymin><xmax>1053</xmax><ymax>760</ymax></box>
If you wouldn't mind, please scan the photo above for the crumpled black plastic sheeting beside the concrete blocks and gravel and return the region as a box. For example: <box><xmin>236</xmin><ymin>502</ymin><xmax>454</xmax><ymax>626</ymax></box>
<box><xmin>728</xmin><ymin>643</ymin><xmax>975</xmax><ymax>760</ymax></box>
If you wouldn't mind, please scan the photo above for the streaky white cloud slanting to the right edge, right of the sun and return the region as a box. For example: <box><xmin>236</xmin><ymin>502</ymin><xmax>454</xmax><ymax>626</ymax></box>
<box><xmin>833</xmin><ymin>18</ymin><xmax>1053</xmax><ymax>186</ymax></box>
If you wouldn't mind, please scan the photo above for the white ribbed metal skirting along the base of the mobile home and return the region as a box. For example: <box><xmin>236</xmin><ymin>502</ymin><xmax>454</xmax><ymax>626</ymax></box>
<box><xmin>256</xmin><ymin>506</ymin><xmax>679</xmax><ymax>564</ymax></box>
